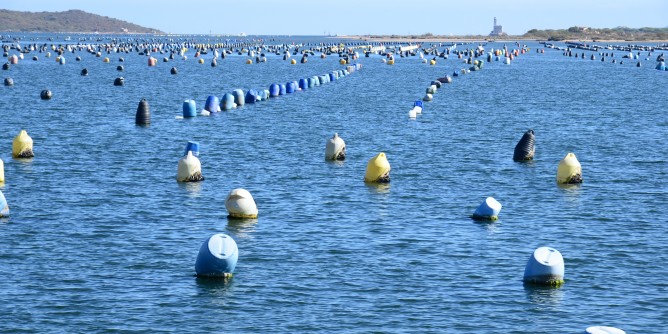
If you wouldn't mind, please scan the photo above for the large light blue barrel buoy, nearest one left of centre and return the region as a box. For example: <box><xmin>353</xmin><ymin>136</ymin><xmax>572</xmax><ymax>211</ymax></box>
<box><xmin>195</xmin><ymin>233</ymin><xmax>239</xmax><ymax>278</ymax></box>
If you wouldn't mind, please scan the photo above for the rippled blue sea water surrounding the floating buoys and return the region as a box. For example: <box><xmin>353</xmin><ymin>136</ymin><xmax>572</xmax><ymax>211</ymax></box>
<box><xmin>0</xmin><ymin>38</ymin><xmax>668</xmax><ymax>333</ymax></box>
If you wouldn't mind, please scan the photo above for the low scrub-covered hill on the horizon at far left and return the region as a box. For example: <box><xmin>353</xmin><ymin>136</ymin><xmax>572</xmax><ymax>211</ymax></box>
<box><xmin>0</xmin><ymin>9</ymin><xmax>162</xmax><ymax>33</ymax></box>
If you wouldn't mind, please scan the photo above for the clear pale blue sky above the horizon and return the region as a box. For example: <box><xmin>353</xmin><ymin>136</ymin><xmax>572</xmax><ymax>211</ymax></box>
<box><xmin>0</xmin><ymin>0</ymin><xmax>668</xmax><ymax>35</ymax></box>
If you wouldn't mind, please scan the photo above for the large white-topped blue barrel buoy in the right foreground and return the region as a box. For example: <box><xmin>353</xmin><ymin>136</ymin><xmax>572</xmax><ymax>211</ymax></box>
<box><xmin>524</xmin><ymin>247</ymin><xmax>564</xmax><ymax>287</ymax></box>
